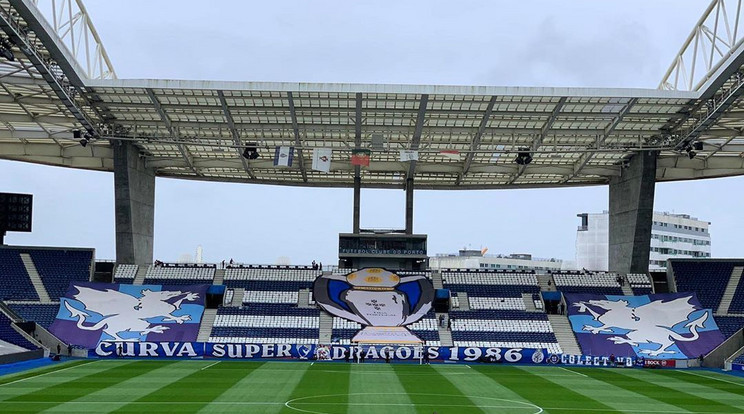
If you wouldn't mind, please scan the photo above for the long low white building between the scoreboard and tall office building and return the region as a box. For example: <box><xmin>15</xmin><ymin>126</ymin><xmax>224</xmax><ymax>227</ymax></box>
<box><xmin>429</xmin><ymin>250</ymin><xmax>575</xmax><ymax>272</ymax></box>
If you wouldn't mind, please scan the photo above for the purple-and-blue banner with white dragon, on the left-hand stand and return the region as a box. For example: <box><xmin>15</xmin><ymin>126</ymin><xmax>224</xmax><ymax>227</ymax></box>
<box><xmin>50</xmin><ymin>282</ymin><xmax>208</xmax><ymax>348</ymax></box>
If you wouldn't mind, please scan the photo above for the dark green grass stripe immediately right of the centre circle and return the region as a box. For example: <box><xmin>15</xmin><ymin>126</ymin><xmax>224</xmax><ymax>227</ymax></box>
<box><xmin>473</xmin><ymin>365</ymin><xmax>622</xmax><ymax>414</ymax></box>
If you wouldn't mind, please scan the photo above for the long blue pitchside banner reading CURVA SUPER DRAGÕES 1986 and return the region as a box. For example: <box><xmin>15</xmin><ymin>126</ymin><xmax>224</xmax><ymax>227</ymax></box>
<box><xmin>89</xmin><ymin>341</ymin><xmax>548</xmax><ymax>364</ymax></box>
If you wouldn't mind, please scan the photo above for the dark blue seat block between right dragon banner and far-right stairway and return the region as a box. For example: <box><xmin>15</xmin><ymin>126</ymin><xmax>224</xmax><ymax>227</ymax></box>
<box><xmin>669</xmin><ymin>260</ymin><xmax>741</xmax><ymax>310</ymax></box>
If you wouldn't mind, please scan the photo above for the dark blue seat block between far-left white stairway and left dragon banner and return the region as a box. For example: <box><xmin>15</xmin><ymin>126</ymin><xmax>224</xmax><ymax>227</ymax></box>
<box><xmin>28</xmin><ymin>249</ymin><xmax>93</xmax><ymax>300</ymax></box>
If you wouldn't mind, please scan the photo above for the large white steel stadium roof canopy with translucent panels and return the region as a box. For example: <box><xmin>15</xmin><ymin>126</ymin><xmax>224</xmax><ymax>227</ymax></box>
<box><xmin>0</xmin><ymin>0</ymin><xmax>744</xmax><ymax>189</ymax></box>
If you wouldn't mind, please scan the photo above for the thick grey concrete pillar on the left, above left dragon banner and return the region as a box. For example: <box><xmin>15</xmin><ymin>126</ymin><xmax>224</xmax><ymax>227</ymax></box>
<box><xmin>111</xmin><ymin>141</ymin><xmax>155</xmax><ymax>265</ymax></box>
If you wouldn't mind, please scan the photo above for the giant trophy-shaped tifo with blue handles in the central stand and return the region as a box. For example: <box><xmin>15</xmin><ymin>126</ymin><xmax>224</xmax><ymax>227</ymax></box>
<box><xmin>313</xmin><ymin>268</ymin><xmax>434</xmax><ymax>343</ymax></box>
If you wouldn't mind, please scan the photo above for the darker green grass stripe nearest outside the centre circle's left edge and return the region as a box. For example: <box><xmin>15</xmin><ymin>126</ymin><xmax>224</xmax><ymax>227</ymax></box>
<box><xmin>107</xmin><ymin>360</ymin><xmax>259</xmax><ymax>413</ymax></box>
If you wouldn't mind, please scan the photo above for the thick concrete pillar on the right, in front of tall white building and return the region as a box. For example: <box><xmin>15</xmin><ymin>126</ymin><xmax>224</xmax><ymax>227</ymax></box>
<box><xmin>609</xmin><ymin>151</ymin><xmax>659</xmax><ymax>273</ymax></box>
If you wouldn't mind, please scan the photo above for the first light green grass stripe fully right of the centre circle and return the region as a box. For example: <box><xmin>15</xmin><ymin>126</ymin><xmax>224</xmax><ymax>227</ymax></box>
<box><xmin>520</xmin><ymin>366</ymin><xmax>680</xmax><ymax>412</ymax></box>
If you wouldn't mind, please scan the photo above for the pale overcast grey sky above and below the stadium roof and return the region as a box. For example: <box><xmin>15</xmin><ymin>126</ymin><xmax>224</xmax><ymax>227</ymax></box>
<box><xmin>0</xmin><ymin>0</ymin><xmax>744</xmax><ymax>264</ymax></box>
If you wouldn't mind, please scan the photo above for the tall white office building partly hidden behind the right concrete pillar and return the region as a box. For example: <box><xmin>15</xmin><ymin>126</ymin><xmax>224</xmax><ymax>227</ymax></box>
<box><xmin>576</xmin><ymin>211</ymin><xmax>710</xmax><ymax>271</ymax></box>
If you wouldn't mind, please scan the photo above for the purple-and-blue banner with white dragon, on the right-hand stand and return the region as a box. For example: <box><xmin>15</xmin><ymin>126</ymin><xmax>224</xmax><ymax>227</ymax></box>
<box><xmin>565</xmin><ymin>293</ymin><xmax>724</xmax><ymax>359</ymax></box>
